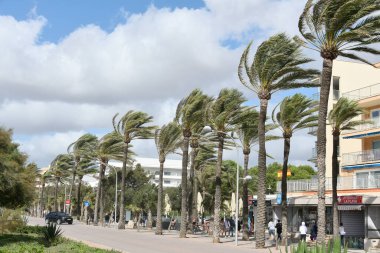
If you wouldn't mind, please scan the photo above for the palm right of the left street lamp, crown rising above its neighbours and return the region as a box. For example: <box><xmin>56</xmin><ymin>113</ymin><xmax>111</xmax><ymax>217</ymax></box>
<box><xmin>112</xmin><ymin>111</ymin><xmax>156</xmax><ymax>229</ymax></box>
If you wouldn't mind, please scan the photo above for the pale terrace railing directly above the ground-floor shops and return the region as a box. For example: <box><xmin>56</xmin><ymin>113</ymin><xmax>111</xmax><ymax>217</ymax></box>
<box><xmin>277</xmin><ymin>175</ymin><xmax>380</xmax><ymax>192</ymax></box>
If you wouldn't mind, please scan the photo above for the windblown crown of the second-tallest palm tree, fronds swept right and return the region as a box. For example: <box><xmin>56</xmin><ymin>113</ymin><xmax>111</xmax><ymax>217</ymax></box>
<box><xmin>238</xmin><ymin>33</ymin><xmax>319</xmax><ymax>99</ymax></box>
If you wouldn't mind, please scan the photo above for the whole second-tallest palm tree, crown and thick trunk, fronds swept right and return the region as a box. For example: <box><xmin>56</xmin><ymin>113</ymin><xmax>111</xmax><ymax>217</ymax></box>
<box><xmin>238</xmin><ymin>33</ymin><xmax>318</xmax><ymax>248</ymax></box>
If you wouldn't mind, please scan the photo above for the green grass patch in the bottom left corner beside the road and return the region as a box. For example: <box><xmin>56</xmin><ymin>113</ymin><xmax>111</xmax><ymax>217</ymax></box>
<box><xmin>0</xmin><ymin>229</ymin><xmax>118</xmax><ymax>253</ymax></box>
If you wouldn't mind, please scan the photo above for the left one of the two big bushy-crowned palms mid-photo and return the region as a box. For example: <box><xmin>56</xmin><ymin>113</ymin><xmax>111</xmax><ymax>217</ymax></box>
<box><xmin>175</xmin><ymin>89</ymin><xmax>209</xmax><ymax>238</ymax></box>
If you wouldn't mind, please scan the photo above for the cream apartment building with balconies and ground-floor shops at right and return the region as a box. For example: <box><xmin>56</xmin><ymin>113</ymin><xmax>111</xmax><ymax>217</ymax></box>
<box><xmin>274</xmin><ymin>60</ymin><xmax>380</xmax><ymax>250</ymax></box>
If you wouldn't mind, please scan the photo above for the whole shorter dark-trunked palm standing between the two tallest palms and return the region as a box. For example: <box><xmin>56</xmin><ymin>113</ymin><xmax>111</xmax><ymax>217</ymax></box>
<box><xmin>272</xmin><ymin>93</ymin><xmax>318</xmax><ymax>245</ymax></box>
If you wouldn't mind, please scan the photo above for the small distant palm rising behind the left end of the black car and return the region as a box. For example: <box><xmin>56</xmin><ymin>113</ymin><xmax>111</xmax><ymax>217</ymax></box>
<box><xmin>50</xmin><ymin>154</ymin><xmax>75</xmax><ymax>211</ymax></box>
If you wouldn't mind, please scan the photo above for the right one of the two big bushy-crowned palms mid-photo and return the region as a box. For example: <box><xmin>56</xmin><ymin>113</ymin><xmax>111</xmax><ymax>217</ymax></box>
<box><xmin>207</xmin><ymin>89</ymin><xmax>245</xmax><ymax>243</ymax></box>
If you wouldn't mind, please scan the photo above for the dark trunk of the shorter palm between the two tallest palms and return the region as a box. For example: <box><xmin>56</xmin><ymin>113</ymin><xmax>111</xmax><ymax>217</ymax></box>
<box><xmin>281</xmin><ymin>136</ymin><xmax>290</xmax><ymax>246</ymax></box>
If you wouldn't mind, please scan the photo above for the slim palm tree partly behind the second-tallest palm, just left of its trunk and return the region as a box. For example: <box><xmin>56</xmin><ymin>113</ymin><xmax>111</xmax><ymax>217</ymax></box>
<box><xmin>236</xmin><ymin>109</ymin><xmax>259</xmax><ymax>241</ymax></box>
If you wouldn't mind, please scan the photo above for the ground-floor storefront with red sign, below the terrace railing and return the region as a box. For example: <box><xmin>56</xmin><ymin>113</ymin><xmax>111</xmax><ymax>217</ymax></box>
<box><xmin>272</xmin><ymin>195</ymin><xmax>380</xmax><ymax>250</ymax></box>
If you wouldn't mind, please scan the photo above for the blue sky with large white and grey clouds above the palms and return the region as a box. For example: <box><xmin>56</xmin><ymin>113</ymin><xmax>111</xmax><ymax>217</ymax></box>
<box><xmin>0</xmin><ymin>0</ymin><xmax>320</xmax><ymax>167</ymax></box>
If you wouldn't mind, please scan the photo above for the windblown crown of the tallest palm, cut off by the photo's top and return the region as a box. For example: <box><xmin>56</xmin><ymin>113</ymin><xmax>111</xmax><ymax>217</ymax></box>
<box><xmin>298</xmin><ymin>0</ymin><xmax>380</xmax><ymax>64</ymax></box>
